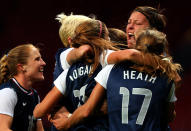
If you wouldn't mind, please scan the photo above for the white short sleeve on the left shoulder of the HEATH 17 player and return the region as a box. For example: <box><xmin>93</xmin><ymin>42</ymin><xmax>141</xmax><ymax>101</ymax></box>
<box><xmin>95</xmin><ymin>64</ymin><xmax>114</xmax><ymax>89</ymax></box>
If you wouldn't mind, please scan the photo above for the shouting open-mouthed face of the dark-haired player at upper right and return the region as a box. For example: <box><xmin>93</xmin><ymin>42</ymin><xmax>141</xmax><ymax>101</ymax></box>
<box><xmin>126</xmin><ymin>11</ymin><xmax>150</xmax><ymax>48</ymax></box>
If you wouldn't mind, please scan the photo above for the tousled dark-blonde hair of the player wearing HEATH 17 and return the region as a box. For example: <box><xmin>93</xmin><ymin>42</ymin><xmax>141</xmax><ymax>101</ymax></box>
<box><xmin>134</xmin><ymin>29</ymin><xmax>182</xmax><ymax>80</ymax></box>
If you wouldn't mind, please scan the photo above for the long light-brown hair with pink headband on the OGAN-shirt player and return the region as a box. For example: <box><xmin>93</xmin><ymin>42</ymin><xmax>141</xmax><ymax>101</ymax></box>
<box><xmin>72</xmin><ymin>20</ymin><xmax>118</xmax><ymax>75</ymax></box>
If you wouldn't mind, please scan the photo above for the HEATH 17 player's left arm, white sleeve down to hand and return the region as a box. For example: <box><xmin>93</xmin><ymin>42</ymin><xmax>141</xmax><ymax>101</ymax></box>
<box><xmin>52</xmin><ymin>65</ymin><xmax>113</xmax><ymax>130</ymax></box>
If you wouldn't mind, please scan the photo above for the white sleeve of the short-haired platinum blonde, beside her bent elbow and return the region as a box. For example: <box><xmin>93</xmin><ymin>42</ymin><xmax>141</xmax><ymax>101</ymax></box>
<box><xmin>60</xmin><ymin>48</ymin><xmax>73</xmax><ymax>70</ymax></box>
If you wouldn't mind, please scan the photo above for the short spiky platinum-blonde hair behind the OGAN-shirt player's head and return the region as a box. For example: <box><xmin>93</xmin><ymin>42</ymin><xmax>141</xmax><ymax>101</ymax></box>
<box><xmin>56</xmin><ymin>13</ymin><xmax>92</xmax><ymax>47</ymax></box>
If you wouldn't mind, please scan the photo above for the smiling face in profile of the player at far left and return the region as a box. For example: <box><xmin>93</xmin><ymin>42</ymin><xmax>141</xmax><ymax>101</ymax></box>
<box><xmin>23</xmin><ymin>47</ymin><xmax>46</xmax><ymax>82</ymax></box>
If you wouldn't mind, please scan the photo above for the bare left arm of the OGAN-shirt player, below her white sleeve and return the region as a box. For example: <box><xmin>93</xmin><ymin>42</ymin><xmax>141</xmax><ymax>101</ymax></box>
<box><xmin>33</xmin><ymin>86</ymin><xmax>63</xmax><ymax>118</ymax></box>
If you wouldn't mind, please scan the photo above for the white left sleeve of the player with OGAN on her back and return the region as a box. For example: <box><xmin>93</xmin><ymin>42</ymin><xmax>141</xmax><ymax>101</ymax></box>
<box><xmin>54</xmin><ymin>69</ymin><xmax>68</xmax><ymax>95</ymax></box>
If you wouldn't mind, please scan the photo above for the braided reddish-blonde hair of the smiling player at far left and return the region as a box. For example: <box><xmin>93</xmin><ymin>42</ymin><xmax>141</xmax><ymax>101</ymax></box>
<box><xmin>0</xmin><ymin>44</ymin><xmax>36</xmax><ymax>84</ymax></box>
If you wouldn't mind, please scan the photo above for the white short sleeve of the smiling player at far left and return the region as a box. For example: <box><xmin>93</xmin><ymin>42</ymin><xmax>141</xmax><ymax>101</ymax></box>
<box><xmin>0</xmin><ymin>88</ymin><xmax>17</xmax><ymax>117</ymax></box>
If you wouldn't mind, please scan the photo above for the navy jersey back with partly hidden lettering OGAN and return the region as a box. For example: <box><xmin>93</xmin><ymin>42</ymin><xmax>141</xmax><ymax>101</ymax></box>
<box><xmin>66</xmin><ymin>62</ymin><xmax>102</xmax><ymax>110</ymax></box>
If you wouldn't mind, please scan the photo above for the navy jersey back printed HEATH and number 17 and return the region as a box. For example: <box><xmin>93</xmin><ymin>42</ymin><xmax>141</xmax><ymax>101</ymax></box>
<box><xmin>107</xmin><ymin>63</ymin><xmax>171</xmax><ymax>131</ymax></box>
